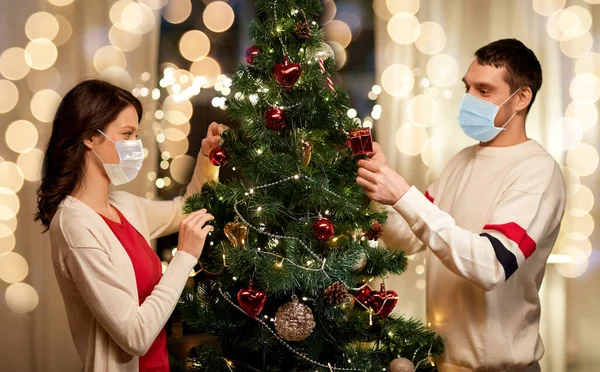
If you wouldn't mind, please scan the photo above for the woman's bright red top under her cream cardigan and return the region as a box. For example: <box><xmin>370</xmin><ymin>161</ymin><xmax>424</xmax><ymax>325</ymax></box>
<box><xmin>100</xmin><ymin>207</ymin><xmax>170</xmax><ymax>372</ymax></box>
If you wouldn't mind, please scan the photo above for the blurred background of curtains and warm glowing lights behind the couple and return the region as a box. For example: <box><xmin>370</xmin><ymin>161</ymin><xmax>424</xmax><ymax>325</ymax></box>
<box><xmin>0</xmin><ymin>0</ymin><xmax>600</xmax><ymax>372</ymax></box>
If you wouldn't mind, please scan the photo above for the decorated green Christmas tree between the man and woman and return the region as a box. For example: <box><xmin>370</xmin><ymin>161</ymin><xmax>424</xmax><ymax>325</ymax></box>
<box><xmin>180</xmin><ymin>0</ymin><xmax>443</xmax><ymax>372</ymax></box>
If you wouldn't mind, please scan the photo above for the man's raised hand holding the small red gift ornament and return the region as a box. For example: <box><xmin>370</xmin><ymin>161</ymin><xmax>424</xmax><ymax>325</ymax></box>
<box><xmin>356</xmin><ymin>160</ymin><xmax>410</xmax><ymax>205</ymax></box>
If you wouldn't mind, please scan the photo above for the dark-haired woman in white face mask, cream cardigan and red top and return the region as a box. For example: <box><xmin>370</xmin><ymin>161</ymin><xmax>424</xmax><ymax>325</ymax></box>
<box><xmin>35</xmin><ymin>80</ymin><xmax>227</xmax><ymax>372</ymax></box>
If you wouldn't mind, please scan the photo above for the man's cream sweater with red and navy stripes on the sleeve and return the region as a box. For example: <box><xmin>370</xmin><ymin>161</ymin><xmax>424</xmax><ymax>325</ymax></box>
<box><xmin>382</xmin><ymin>140</ymin><xmax>565</xmax><ymax>372</ymax></box>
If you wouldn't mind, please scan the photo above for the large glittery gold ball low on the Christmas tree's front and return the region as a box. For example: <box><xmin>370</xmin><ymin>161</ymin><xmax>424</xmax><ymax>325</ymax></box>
<box><xmin>275</xmin><ymin>296</ymin><xmax>315</xmax><ymax>341</ymax></box>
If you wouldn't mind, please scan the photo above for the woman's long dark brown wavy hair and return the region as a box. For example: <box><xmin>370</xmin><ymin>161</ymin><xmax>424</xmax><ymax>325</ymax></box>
<box><xmin>34</xmin><ymin>80</ymin><xmax>142</xmax><ymax>232</ymax></box>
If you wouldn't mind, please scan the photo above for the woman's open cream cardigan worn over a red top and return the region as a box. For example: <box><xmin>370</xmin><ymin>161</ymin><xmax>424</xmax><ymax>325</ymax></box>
<box><xmin>50</xmin><ymin>157</ymin><xmax>218</xmax><ymax>372</ymax></box>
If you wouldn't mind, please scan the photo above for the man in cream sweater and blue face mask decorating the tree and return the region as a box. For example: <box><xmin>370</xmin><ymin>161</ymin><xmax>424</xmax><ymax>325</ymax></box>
<box><xmin>357</xmin><ymin>39</ymin><xmax>565</xmax><ymax>372</ymax></box>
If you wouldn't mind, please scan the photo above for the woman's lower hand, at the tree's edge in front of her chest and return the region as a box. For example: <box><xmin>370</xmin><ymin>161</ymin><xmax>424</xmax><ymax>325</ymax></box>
<box><xmin>177</xmin><ymin>209</ymin><xmax>214</xmax><ymax>259</ymax></box>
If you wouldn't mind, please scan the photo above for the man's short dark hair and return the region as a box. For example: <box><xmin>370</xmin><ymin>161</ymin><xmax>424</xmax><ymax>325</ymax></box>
<box><xmin>475</xmin><ymin>39</ymin><xmax>542</xmax><ymax>113</ymax></box>
